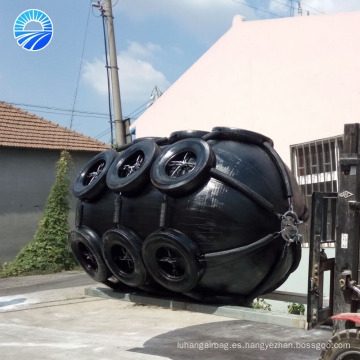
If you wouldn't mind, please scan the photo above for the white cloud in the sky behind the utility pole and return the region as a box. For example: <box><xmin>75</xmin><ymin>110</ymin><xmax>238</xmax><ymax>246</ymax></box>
<box><xmin>82</xmin><ymin>42</ymin><xmax>170</xmax><ymax>103</ymax></box>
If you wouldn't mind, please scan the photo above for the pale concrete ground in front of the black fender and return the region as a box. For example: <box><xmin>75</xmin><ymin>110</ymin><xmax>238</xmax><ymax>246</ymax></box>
<box><xmin>0</xmin><ymin>272</ymin><xmax>331</xmax><ymax>360</ymax></box>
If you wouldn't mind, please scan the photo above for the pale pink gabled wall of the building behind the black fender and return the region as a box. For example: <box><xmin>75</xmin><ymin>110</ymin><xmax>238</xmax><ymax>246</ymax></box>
<box><xmin>135</xmin><ymin>12</ymin><xmax>360</xmax><ymax>166</ymax></box>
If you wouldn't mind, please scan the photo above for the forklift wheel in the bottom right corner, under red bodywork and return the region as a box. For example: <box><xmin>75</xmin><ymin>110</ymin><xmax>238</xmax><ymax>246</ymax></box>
<box><xmin>320</xmin><ymin>329</ymin><xmax>360</xmax><ymax>360</ymax></box>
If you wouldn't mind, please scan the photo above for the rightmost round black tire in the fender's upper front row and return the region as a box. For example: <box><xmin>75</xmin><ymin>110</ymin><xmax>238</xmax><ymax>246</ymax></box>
<box><xmin>151</xmin><ymin>138</ymin><xmax>216</xmax><ymax>195</ymax></box>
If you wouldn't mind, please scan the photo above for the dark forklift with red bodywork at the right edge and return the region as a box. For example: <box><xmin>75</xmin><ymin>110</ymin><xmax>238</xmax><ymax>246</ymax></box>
<box><xmin>307</xmin><ymin>124</ymin><xmax>360</xmax><ymax>360</ymax></box>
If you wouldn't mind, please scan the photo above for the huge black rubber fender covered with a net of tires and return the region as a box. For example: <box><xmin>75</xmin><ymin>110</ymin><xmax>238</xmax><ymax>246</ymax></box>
<box><xmin>69</xmin><ymin>127</ymin><xmax>307</xmax><ymax>305</ymax></box>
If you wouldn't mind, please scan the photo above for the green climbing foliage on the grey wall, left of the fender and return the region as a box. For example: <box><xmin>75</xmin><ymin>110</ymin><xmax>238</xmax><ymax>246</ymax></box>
<box><xmin>0</xmin><ymin>151</ymin><xmax>76</xmax><ymax>277</ymax></box>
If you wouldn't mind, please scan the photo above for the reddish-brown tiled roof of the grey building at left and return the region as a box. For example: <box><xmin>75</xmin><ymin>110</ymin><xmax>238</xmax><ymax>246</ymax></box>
<box><xmin>0</xmin><ymin>101</ymin><xmax>109</xmax><ymax>151</ymax></box>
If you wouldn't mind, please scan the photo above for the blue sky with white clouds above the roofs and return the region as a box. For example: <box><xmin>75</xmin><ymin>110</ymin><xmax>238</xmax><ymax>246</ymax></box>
<box><xmin>0</xmin><ymin>0</ymin><xmax>360</xmax><ymax>143</ymax></box>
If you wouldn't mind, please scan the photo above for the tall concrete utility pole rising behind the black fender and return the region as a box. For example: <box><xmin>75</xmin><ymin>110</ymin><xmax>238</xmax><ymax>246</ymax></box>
<box><xmin>104</xmin><ymin>0</ymin><xmax>125</xmax><ymax>146</ymax></box>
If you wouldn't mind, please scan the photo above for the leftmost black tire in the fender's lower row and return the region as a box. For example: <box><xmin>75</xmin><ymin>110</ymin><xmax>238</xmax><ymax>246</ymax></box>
<box><xmin>68</xmin><ymin>227</ymin><xmax>112</xmax><ymax>283</ymax></box>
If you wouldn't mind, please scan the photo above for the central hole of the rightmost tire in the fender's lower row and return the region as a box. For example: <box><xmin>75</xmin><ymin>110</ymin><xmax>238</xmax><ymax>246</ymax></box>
<box><xmin>156</xmin><ymin>247</ymin><xmax>186</xmax><ymax>279</ymax></box>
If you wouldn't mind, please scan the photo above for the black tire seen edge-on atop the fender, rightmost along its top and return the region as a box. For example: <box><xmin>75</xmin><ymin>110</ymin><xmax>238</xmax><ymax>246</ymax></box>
<box><xmin>208</xmin><ymin>126</ymin><xmax>274</xmax><ymax>146</ymax></box>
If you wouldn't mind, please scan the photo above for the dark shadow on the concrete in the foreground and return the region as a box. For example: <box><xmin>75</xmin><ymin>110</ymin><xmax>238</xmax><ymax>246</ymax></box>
<box><xmin>129</xmin><ymin>315</ymin><xmax>331</xmax><ymax>360</ymax></box>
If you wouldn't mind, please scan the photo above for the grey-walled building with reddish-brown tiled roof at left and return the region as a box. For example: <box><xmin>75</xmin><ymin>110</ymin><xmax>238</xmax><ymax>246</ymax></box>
<box><xmin>0</xmin><ymin>101</ymin><xmax>108</xmax><ymax>264</ymax></box>
